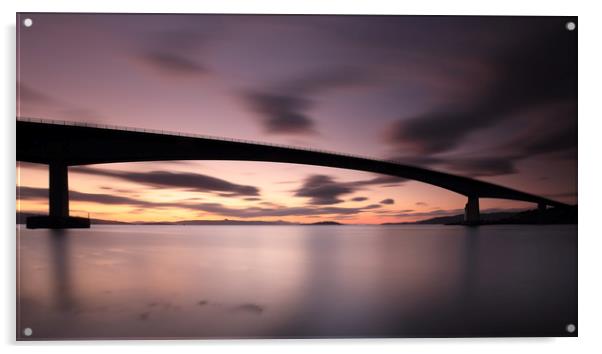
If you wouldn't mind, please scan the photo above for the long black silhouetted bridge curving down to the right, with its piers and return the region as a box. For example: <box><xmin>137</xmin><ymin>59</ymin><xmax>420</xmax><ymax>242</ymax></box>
<box><xmin>16</xmin><ymin>118</ymin><xmax>569</xmax><ymax>228</ymax></box>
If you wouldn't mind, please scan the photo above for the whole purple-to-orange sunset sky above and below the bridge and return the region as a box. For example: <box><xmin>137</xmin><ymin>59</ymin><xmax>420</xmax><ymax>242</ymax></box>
<box><xmin>17</xmin><ymin>14</ymin><xmax>577</xmax><ymax>224</ymax></box>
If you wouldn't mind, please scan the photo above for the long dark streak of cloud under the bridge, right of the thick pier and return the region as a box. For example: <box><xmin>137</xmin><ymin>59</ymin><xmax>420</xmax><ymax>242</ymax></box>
<box><xmin>71</xmin><ymin>166</ymin><xmax>259</xmax><ymax>197</ymax></box>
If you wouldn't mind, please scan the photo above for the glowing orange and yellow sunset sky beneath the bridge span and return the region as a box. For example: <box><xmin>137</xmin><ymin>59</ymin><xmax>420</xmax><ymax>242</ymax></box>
<box><xmin>17</xmin><ymin>161</ymin><xmax>560</xmax><ymax>224</ymax></box>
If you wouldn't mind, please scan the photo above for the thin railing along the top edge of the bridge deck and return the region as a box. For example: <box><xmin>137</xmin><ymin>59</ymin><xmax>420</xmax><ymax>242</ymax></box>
<box><xmin>17</xmin><ymin>117</ymin><xmax>410</xmax><ymax>164</ymax></box>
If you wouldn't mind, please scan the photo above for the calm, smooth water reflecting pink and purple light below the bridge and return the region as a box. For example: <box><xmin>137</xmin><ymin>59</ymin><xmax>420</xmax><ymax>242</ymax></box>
<box><xmin>17</xmin><ymin>225</ymin><xmax>577</xmax><ymax>339</ymax></box>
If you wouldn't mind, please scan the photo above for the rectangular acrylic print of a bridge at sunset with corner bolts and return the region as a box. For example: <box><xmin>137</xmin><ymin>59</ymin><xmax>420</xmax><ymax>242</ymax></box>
<box><xmin>16</xmin><ymin>13</ymin><xmax>578</xmax><ymax>340</ymax></box>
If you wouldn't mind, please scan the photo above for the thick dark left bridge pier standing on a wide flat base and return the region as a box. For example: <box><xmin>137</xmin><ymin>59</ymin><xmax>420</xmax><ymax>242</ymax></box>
<box><xmin>27</xmin><ymin>162</ymin><xmax>90</xmax><ymax>229</ymax></box>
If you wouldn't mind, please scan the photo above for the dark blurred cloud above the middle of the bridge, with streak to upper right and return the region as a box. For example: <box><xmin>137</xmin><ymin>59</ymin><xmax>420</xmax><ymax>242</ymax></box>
<box><xmin>242</xmin><ymin>68</ymin><xmax>370</xmax><ymax>135</ymax></box>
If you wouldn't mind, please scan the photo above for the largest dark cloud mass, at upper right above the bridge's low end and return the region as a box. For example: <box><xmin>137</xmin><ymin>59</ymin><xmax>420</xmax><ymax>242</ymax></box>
<box><xmin>384</xmin><ymin>21</ymin><xmax>577</xmax><ymax>176</ymax></box>
